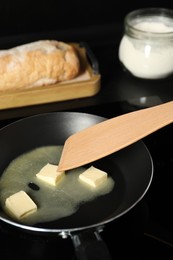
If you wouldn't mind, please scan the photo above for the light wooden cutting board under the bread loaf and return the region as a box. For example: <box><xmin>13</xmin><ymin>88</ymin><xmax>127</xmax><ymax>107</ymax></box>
<box><xmin>0</xmin><ymin>43</ymin><xmax>101</xmax><ymax>110</ymax></box>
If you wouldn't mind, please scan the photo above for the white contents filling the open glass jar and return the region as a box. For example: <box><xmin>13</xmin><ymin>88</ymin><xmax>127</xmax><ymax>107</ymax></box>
<box><xmin>119</xmin><ymin>17</ymin><xmax>173</xmax><ymax>79</ymax></box>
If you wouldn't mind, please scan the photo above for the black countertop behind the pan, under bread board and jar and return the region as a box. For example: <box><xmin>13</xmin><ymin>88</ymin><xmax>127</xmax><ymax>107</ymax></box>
<box><xmin>0</xmin><ymin>24</ymin><xmax>173</xmax><ymax>124</ymax></box>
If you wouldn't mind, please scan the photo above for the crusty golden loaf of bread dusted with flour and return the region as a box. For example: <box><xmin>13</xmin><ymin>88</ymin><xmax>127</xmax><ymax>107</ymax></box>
<box><xmin>0</xmin><ymin>40</ymin><xmax>80</xmax><ymax>91</ymax></box>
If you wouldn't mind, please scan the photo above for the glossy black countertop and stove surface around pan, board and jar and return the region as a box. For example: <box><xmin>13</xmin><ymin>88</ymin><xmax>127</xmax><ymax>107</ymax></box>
<box><xmin>0</xmin><ymin>24</ymin><xmax>173</xmax><ymax>259</ymax></box>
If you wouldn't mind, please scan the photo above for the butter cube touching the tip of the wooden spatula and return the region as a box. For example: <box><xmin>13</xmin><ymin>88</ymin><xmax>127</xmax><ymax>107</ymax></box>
<box><xmin>36</xmin><ymin>163</ymin><xmax>64</xmax><ymax>186</ymax></box>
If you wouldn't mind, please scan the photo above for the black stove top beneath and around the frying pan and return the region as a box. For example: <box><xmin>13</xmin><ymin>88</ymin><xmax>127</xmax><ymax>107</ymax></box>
<box><xmin>0</xmin><ymin>102</ymin><xmax>173</xmax><ymax>260</ymax></box>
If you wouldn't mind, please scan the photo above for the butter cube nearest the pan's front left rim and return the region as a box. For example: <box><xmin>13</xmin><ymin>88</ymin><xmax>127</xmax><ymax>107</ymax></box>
<box><xmin>5</xmin><ymin>190</ymin><xmax>37</xmax><ymax>219</ymax></box>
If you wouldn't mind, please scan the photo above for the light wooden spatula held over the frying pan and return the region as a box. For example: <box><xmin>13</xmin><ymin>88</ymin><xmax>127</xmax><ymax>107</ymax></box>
<box><xmin>58</xmin><ymin>101</ymin><xmax>173</xmax><ymax>171</ymax></box>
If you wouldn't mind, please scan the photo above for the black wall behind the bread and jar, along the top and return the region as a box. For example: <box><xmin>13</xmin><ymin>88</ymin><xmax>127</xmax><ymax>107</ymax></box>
<box><xmin>0</xmin><ymin>0</ymin><xmax>173</xmax><ymax>36</ymax></box>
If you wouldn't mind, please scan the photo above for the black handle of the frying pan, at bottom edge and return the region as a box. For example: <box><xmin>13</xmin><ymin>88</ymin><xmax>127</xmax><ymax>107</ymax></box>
<box><xmin>71</xmin><ymin>229</ymin><xmax>112</xmax><ymax>260</ymax></box>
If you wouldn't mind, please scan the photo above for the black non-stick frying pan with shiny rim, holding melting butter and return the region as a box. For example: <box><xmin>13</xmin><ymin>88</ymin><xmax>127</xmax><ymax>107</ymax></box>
<box><xmin>0</xmin><ymin>112</ymin><xmax>153</xmax><ymax>260</ymax></box>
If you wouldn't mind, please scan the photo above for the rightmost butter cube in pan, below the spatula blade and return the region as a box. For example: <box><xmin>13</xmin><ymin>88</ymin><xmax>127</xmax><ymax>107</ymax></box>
<box><xmin>79</xmin><ymin>166</ymin><xmax>108</xmax><ymax>188</ymax></box>
